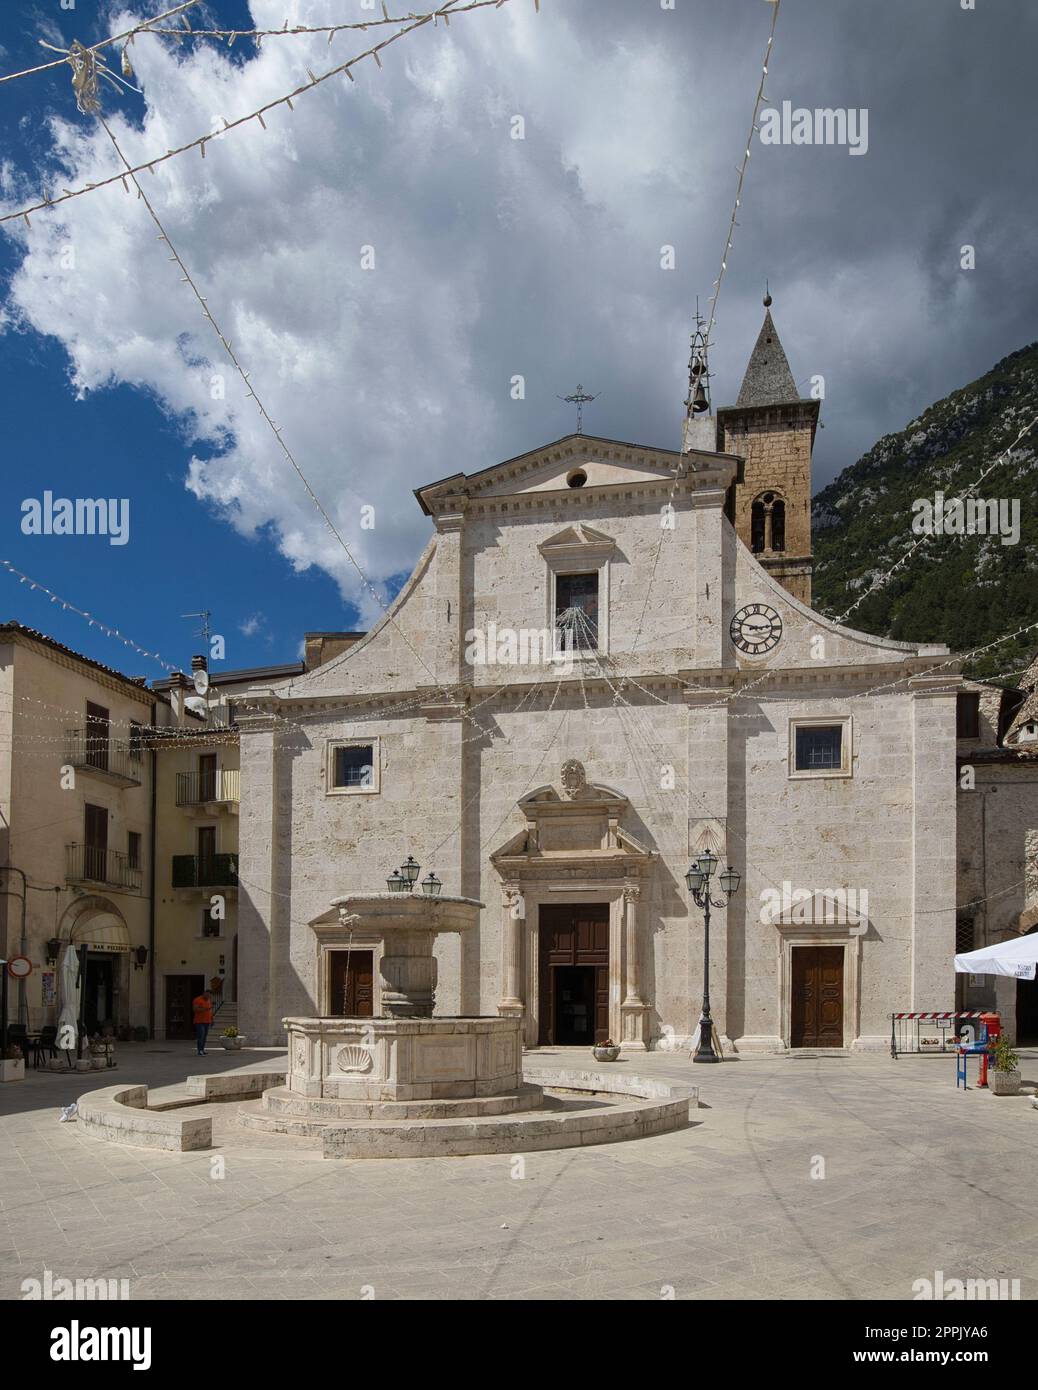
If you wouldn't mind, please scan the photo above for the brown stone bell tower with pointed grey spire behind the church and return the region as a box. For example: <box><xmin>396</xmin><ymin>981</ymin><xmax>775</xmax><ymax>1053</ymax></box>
<box><xmin>717</xmin><ymin>293</ymin><xmax>818</xmax><ymax>605</ymax></box>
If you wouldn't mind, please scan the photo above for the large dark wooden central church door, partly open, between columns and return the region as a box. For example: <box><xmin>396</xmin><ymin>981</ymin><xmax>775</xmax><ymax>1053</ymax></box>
<box><xmin>538</xmin><ymin>902</ymin><xmax>609</xmax><ymax>1047</ymax></box>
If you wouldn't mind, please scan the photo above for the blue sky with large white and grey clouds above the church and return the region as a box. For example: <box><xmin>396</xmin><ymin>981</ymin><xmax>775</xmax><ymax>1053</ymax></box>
<box><xmin>0</xmin><ymin>0</ymin><xmax>1038</xmax><ymax>676</ymax></box>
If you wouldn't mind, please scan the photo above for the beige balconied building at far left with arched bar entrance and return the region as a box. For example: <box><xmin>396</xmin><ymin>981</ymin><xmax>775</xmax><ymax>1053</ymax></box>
<box><xmin>0</xmin><ymin>623</ymin><xmax>161</xmax><ymax>1033</ymax></box>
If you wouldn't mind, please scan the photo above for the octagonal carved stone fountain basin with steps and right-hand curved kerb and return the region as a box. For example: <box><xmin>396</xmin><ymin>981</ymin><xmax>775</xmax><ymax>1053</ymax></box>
<box><xmin>239</xmin><ymin>1017</ymin><xmax>699</xmax><ymax>1158</ymax></box>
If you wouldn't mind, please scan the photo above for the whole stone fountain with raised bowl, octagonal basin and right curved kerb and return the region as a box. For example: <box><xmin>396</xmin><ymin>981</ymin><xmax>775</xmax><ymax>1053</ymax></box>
<box><xmin>240</xmin><ymin>892</ymin><xmax>695</xmax><ymax>1158</ymax></box>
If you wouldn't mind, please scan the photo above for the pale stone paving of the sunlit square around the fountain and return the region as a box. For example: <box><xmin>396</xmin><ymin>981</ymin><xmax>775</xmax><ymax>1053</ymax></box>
<box><xmin>0</xmin><ymin>1044</ymin><xmax>1038</xmax><ymax>1301</ymax></box>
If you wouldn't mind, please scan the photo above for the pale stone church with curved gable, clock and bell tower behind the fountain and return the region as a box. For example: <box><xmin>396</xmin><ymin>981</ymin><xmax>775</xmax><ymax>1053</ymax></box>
<box><xmin>238</xmin><ymin>311</ymin><xmax>960</xmax><ymax>1054</ymax></box>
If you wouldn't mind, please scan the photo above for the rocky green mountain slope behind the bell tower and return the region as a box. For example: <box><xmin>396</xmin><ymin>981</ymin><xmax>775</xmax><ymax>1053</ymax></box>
<box><xmin>813</xmin><ymin>342</ymin><xmax>1038</xmax><ymax>684</ymax></box>
